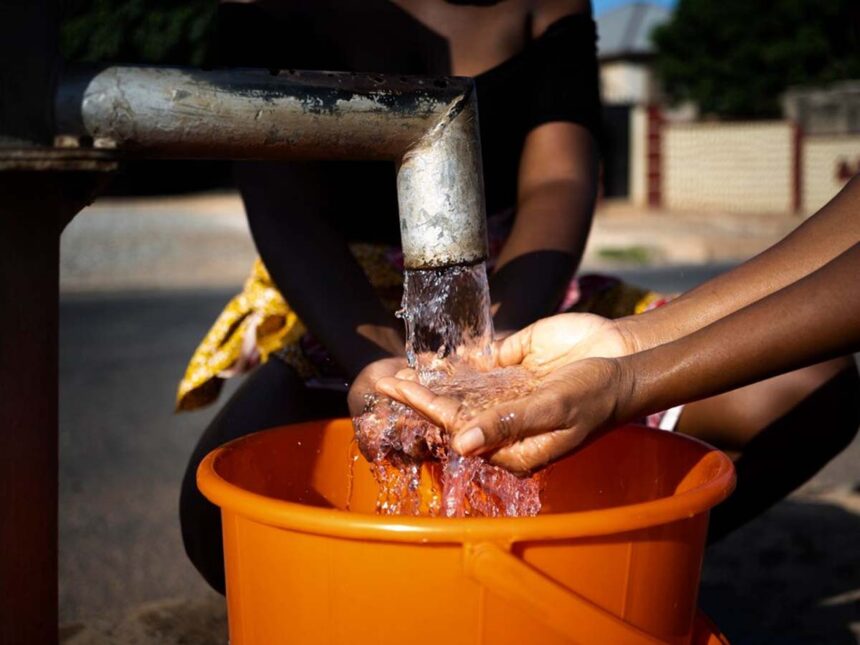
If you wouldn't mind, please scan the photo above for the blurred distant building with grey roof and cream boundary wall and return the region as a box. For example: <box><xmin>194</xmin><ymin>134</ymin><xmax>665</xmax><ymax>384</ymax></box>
<box><xmin>597</xmin><ymin>2</ymin><xmax>860</xmax><ymax>215</ymax></box>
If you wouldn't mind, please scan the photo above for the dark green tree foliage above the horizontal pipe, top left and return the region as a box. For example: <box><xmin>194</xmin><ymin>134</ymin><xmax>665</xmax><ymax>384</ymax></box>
<box><xmin>61</xmin><ymin>0</ymin><xmax>218</xmax><ymax>65</ymax></box>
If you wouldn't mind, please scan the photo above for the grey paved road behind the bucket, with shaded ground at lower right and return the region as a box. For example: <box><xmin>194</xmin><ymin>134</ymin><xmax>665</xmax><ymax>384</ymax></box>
<box><xmin>60</xmin><ymin>266</ymin><xmax>860</xmax><ymax>643</ymax></box>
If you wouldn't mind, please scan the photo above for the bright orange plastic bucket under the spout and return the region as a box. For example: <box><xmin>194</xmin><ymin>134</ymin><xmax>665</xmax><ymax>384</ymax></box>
<box><xmin>197</xmin><ymin>419</ymin><xmax>734</xmax><ymax>645</ymax></box>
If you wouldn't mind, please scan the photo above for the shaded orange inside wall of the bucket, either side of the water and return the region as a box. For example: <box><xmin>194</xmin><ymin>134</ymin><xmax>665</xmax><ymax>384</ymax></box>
<box><xmin>213</xmin><ymin>419</ymin><xmax>727</xmax><ymax>515</ymax></box>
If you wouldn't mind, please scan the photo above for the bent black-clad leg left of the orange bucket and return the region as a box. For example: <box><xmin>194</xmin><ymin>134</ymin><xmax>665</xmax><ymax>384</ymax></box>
<box><xmin>179</xmin><ymin>358</ymin><xmax>349</xmax><ymax>593</ymax></box>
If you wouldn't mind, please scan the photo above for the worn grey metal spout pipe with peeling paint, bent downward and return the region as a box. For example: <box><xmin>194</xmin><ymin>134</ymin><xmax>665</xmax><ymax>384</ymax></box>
<box><xmin>55</xmin><ymin>67</ymin><xmax>487</xmax><ymax>269</ymax></box>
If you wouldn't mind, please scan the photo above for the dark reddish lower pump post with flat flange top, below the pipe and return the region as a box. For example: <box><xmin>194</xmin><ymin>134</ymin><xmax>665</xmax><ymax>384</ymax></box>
<box><xmin>0</xmin><ymin>148</ymin><xmax>116</xmax><ymax>645</ymax></box>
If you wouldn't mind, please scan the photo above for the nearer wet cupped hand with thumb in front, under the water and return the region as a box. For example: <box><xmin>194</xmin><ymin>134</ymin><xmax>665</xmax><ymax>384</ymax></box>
<box><xmin>376</xmin><ymin>358</ymin><xmax>632</xmax><ymax>474</ymax></box>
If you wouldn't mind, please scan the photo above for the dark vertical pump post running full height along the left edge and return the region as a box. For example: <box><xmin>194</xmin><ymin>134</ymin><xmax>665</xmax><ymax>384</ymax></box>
<box><xmin>0</xmin><ymin>0</ymin><xmax>69</xmax><ymax>645</ymax></box>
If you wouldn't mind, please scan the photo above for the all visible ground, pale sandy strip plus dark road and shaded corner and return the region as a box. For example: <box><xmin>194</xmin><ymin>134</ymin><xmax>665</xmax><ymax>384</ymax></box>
<box><xmin>60</xmin><ymin>194</ymin><xmax>860</xmax><ymax>645</ymax></box>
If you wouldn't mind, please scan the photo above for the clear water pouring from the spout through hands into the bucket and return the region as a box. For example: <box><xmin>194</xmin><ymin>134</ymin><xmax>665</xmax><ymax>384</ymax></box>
<box><xmin>354</xmin><ymin>263</ymin><xmax>542</xmax><ymax>517</ymax></box>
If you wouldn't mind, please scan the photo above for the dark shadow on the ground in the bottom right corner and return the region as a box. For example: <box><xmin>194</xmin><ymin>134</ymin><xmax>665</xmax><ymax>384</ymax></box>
<box><xmin>699</xmin><ymin>493</ymin><xmax>860</xmax><ymax>645</ymax></box>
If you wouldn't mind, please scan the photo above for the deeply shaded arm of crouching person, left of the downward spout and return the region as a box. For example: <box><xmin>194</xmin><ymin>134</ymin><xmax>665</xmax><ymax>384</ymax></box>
<box><xmin>236</xmin><ymin>163</ymin><xmax>403</xmax><ymax>376</ymax></box>
